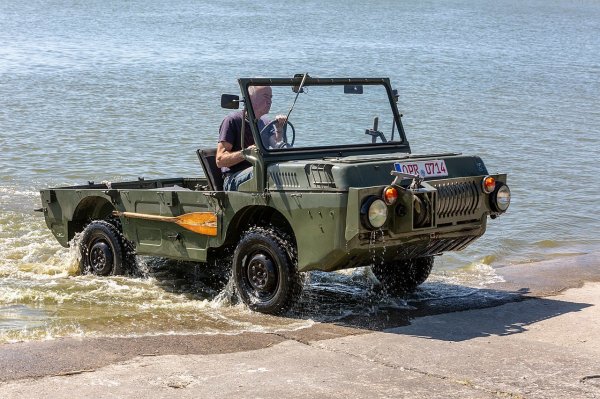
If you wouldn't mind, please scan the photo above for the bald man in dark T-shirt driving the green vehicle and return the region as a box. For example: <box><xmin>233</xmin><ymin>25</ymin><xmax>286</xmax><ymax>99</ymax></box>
<box><xmin>216</xmin><ymin>86</ymin><xmax>286</xmax><ymax>191</ymax></box>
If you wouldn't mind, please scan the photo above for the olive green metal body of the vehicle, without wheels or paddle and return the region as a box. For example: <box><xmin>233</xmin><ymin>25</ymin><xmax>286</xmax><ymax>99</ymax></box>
<box><xmin>41</xmin><ymin>78</ymin><xmax>506</xmax><ymax>272</ymax></box>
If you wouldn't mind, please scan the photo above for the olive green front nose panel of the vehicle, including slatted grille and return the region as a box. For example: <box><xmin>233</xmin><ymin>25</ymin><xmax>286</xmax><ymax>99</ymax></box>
<box><xmin>298</xmin><ymin>174</ymin><xmax>506</xmax><ymax>271</ymax></box>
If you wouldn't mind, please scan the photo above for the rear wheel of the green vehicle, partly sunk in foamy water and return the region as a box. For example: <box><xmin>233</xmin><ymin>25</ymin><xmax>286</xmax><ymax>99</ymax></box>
<box><xmin>79</xmin><ymin>220</ymin><xmax>124</xmax><ymax>276</ymax></box>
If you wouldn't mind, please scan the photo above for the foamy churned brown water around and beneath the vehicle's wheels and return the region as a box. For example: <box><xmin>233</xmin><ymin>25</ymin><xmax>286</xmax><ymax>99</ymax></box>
<box><xmin>0</xmin><ymin>187</ymin><xmax>564</xmax><ymax>342</ymax></box>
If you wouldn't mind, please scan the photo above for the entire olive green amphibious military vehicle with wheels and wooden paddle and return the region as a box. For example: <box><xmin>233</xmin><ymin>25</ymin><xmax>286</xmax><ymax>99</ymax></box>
<box><xmin>41</xmin><ymin>74</ymin><xmax>510</xmax><ymax>313</ymax></box>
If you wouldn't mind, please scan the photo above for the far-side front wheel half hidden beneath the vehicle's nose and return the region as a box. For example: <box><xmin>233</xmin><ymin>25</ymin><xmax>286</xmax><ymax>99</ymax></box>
<box><xmin>371</xmin><ymin>256</ymin><xmax>433</xmax><ymax>295</ymax></box>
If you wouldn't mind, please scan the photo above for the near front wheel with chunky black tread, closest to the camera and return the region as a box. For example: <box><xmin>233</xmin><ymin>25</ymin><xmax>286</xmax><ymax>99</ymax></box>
<box><xmin>233</xmin><ymin>227</ymin><xmax>302</xmax><ymax>314</ymax></box>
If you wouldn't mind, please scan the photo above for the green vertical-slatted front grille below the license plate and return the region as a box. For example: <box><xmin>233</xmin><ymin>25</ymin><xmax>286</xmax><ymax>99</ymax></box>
<box><xmin>432</xmin><ymin>181</ymin><xmax>480</xmax><ymax>219</ymax></box>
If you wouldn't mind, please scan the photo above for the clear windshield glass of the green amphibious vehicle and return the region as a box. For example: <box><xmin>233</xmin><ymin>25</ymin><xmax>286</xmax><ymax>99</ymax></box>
<box><xmin>250</xmin><ymin>84</ymin><xmax>402</xmax><ymax>151</ymax></box>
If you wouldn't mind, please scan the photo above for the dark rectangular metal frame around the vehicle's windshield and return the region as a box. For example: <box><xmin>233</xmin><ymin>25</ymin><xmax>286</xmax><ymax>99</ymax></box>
<box><xmin>238</xmin><ymin>75</ymin><xmax>410</xmax><ymax>159</ymax></box>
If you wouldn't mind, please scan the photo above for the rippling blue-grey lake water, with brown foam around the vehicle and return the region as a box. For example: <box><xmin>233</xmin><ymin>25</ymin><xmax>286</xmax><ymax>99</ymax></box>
<box><xmin>0</xmin><ymin>0</ymin><xmax>600</xmax><ymax>342</ymax></box>
